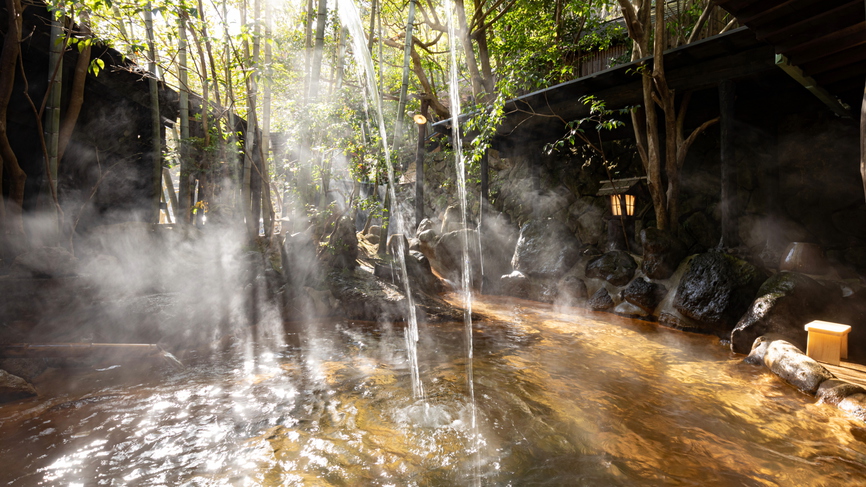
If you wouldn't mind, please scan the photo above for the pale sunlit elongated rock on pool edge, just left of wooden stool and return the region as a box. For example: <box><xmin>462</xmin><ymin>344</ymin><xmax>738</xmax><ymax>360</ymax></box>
<box><xmin>747</xmin><ymin>336</ymin><xmax>835</xmax><ymax>395</ymax></box>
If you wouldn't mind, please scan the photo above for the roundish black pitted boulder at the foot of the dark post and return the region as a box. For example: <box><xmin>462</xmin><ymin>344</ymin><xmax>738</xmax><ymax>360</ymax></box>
<box><xmin>673</xmin><ymin>252</ymin><xmax>760</xmax><ymax>337</ymax></box>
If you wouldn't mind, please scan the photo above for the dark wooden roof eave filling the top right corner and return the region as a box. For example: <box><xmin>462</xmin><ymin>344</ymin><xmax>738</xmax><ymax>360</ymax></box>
<box><xmin>716</xmin><ymin>0</ymin><xmax>866</xmax><ymax>106</ymax></box>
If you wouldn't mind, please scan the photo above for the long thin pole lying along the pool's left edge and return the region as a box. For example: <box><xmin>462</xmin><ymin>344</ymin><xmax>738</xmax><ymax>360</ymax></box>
<box><xmin>0</xmin><ymin>343</ymin><xmax>183</xmax><ymax>368</ymax></box>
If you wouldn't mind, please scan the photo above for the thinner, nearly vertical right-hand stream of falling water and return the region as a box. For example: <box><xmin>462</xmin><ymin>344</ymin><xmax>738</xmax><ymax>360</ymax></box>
<box><xmin>445</xmin><ymin>0</ymin><xmax>480</xmax><ymax>485</ymax></box>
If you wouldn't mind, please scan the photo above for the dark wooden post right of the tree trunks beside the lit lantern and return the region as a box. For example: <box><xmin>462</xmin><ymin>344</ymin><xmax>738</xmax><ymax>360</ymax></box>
<box><xmin>719</xmin><ymin>79</ymin><xmax>737</xmax><ymax>249</ymax></box>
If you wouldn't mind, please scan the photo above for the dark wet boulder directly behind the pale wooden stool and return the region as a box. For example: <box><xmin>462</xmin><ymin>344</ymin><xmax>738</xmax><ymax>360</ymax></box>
<box><xmin>731</xmin><ymin>272</ymin><xmax>842</xmax><ymax>353</ymax></box>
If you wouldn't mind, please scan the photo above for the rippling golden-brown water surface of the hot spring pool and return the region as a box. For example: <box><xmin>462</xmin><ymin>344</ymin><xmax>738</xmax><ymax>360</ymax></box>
<box><xmin>0</xmin><ymin>298</ymin><xmax>866</xmax><ymax>486</ymax></box>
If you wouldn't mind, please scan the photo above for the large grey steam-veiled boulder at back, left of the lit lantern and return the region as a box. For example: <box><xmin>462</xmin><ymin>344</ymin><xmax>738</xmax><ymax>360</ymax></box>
<box><xmin>511</xmin><ymin>218</ymin><xmax>580</xmax><ymax>278</ymax></box>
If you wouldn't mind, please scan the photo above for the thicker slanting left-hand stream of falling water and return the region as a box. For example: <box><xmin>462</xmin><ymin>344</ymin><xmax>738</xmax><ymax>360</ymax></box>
<box><xmin>338</xmin><ymin>0</ymin><xmax>424</xmax><ymax>399</ymax></box>
